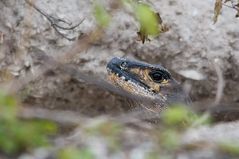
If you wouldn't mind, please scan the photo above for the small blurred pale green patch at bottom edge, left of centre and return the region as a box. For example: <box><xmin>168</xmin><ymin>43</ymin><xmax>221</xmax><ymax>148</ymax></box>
<box><xmin>58</xmin><ymin>147</ymin><xmax>95</xmax><ymax>159</ymax></box>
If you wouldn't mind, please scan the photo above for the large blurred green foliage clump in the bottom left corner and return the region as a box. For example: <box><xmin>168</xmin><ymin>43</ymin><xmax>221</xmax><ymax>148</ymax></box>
<box><xmin>0</xmin><ymin>92</ymin><xmax>57</xmax><ymax>155</ymax></box>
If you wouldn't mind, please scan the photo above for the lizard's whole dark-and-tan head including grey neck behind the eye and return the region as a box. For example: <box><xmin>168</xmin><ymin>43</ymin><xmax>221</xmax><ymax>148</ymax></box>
<box><xmin>107</xmin><ymin>57</ymin><xmax>190</xmax><ymax>106</ymax></box>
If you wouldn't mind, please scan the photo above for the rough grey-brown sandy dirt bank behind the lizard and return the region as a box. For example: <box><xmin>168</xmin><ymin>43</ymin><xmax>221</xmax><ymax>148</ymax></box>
<box><xmin>0</xmin><ymin>0</ymin><xmax>239</xmax><ymax>158</ymax></box>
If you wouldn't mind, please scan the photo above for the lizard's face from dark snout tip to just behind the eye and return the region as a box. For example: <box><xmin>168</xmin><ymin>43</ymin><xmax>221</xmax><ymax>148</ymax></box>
<box><xmin>107</xmin><ymin>57</ymin><xmax>172</xmax><ymax>100</ymax></box>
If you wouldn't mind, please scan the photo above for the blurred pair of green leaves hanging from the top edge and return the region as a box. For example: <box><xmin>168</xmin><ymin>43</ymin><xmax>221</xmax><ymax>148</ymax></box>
<box><xmin>94</xmin><ymin>0</ymin><xmax>163</xmax><ymax>43</ymax></box>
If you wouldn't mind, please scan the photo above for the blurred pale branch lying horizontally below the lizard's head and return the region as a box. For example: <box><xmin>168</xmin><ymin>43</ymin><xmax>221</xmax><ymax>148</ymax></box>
<box><xmin>18</xmin><ymin>106</ymin><xmax>152</xmax><ymax>130</ymax></box>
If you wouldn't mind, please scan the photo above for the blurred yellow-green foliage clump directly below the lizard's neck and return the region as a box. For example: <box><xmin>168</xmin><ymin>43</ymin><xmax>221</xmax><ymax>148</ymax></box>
<box><xmin>148</xmin><ymin>105</ymin><xmax>210</xmax><ymax>158</ymax></box>
